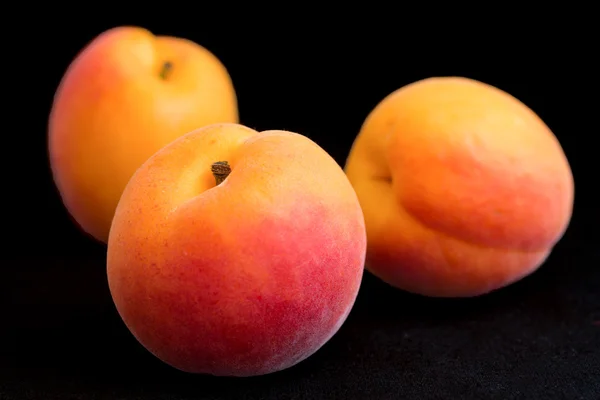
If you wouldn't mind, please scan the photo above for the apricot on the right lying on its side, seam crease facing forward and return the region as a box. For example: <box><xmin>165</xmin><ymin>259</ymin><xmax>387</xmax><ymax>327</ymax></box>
<box><xmin>345</xmin><ymin>77</ymin><xmax>574</xmax><ymax>297</ymax></box>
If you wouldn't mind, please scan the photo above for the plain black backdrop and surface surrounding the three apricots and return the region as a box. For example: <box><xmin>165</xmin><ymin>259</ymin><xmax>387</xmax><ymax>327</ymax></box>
<box><xmin>0</xmin><ymin>12</ymin><xmax>600</xmax><ymax>400</ymax></box>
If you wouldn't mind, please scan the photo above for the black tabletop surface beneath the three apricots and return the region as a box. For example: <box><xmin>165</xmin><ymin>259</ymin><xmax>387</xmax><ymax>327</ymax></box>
<box><xmin>0</xmin><ymin>236</ymin><xmax>600</xmax><ymax>400</ymax></box>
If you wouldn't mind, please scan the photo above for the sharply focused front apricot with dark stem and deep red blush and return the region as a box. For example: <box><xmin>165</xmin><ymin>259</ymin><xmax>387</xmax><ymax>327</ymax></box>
<box><xmin>107</xmin><ymin>124</ymin><xmax>366</xmax><ymax>376</ymax></box>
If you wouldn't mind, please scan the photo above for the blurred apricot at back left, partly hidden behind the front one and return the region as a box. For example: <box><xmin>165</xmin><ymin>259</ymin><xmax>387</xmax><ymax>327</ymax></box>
<box><xmin>48</xmin><ymin>27</ymin><xmax>238</xmax><ymax>242</ymax></box>
